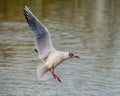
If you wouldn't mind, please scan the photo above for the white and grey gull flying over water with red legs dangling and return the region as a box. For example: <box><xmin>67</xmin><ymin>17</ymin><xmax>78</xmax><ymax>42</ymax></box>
<box><xmin>23</xmin><ymin>5</ymin><xmax>79</xmax><ymax>83</ymax></box>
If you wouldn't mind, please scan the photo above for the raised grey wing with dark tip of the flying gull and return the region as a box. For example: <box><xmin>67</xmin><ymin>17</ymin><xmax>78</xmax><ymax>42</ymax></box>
<box><xmin>24</xmin><ymin>6</ymin><xmax>55</xmax><ymax>60</ymax></box>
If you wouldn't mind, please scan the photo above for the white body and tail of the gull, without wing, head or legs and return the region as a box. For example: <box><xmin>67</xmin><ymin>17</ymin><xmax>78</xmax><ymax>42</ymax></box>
<box><xmin>37</xmin><ymin>51</ymin><xmax>70</xmax><ymax>78</ymax></box>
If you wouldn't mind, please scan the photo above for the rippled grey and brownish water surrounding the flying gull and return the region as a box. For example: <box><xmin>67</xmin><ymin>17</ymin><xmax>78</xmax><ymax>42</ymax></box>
<box><xmin>0</xmin><ymin>0</ymin><xmax>120</xmax><ymax>96</ymax></box>
